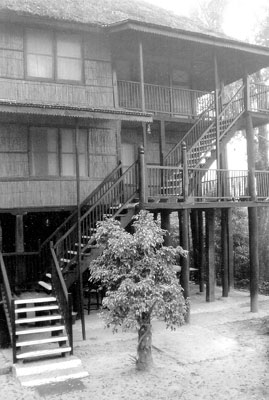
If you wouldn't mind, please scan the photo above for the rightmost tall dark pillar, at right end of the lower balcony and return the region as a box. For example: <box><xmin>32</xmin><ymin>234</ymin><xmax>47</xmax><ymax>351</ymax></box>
<box><xmin>246</xmin><ymin>112</ymin><xmax>259</xmax><ymax>312</ymax></box>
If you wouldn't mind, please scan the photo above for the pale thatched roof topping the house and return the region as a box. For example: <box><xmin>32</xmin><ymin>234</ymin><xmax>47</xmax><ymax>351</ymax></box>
<box><xmin>0</xmin><ymin>0</ymin><xmax>230</xmax><ymax>38</ymax></box>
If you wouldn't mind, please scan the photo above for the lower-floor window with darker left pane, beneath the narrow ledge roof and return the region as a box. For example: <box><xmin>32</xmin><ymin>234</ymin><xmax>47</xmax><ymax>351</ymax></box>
<box><xmin>30</xmin><ymin>127</ymin><xmax>88</xmax><ymax>176</ymax></box>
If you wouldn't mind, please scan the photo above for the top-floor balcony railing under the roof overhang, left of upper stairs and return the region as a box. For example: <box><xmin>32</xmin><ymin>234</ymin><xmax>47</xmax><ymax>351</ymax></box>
<box><xmin>118</xmin><ymin>81</ymin><xmax>214</xmax><ymax>117</ymax></box>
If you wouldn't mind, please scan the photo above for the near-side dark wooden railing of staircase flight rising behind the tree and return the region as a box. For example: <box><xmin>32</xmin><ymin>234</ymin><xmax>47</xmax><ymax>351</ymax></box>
<box><xmin>53</xmin><ymin>162</ymin><xmax>139</xmax><ymax>271</ymax></box>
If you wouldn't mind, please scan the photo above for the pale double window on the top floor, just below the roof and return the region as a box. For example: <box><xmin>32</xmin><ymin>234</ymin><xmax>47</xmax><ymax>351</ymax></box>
<box><xmin>26</xmin><ymin>29</ymin><xmax>82</xmax><ymax>82</ymax></box>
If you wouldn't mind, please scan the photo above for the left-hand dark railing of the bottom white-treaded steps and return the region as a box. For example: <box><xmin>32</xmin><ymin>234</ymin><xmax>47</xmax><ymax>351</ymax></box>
<box><xmin>0</xmin><ymin>253</ymin><xmax>16</xmax><ymax>363</ymax></box>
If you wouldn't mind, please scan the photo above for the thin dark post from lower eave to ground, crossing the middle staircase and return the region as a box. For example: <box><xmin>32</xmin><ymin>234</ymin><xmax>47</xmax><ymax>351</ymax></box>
<box><xmin>75</xmin><ymin>120</ymin><xmax>86</xmax><ymax>340</ymax></box>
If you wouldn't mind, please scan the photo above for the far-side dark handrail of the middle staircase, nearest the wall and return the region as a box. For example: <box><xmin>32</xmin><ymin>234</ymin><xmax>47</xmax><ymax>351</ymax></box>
<box><xmin>38</xmin><ymin>163</ymin><xmax>122</xmax><ymax>275</ymax></box>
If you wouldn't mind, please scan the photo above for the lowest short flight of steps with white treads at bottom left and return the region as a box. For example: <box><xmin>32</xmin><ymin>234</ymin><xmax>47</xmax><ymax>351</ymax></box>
<box><xmin>14</xmin><ymin>292</ymin><xmax>71</xmax><ymax>361</ymax></box>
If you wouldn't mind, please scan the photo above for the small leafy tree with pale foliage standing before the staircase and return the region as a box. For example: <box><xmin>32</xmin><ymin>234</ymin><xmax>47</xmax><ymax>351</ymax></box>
<box><xmin>90</xmin><ymin>211</ymin><xmax>187</xmax><ymax>370</ymax></box>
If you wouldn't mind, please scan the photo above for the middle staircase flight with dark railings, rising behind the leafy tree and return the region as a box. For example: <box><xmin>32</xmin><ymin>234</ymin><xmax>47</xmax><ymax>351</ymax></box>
<box><xmin>39</xmin><ymin>162</ymin><xmax>138</xmax><ymax>293</ymax></box>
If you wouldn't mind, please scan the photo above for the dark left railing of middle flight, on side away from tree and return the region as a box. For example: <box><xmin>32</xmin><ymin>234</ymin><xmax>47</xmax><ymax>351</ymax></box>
<box><xmin>39</xmin><ymin>164</ymin><xmax>122</xmax><ymax>277</ymax></box>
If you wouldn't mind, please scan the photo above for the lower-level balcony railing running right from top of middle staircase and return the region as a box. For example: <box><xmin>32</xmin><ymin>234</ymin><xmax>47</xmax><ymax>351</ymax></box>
<box><xmin>147</xmin><ymin>165</ymin><xmax>269</xmax><ymax>202</ymax></box>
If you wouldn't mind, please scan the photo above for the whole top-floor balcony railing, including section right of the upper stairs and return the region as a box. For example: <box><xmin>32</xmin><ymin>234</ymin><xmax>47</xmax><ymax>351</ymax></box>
<box><xmin>118</xmin><ymin>80</ymin><xmax>269</xmax><ymax>119</ymax></box>
